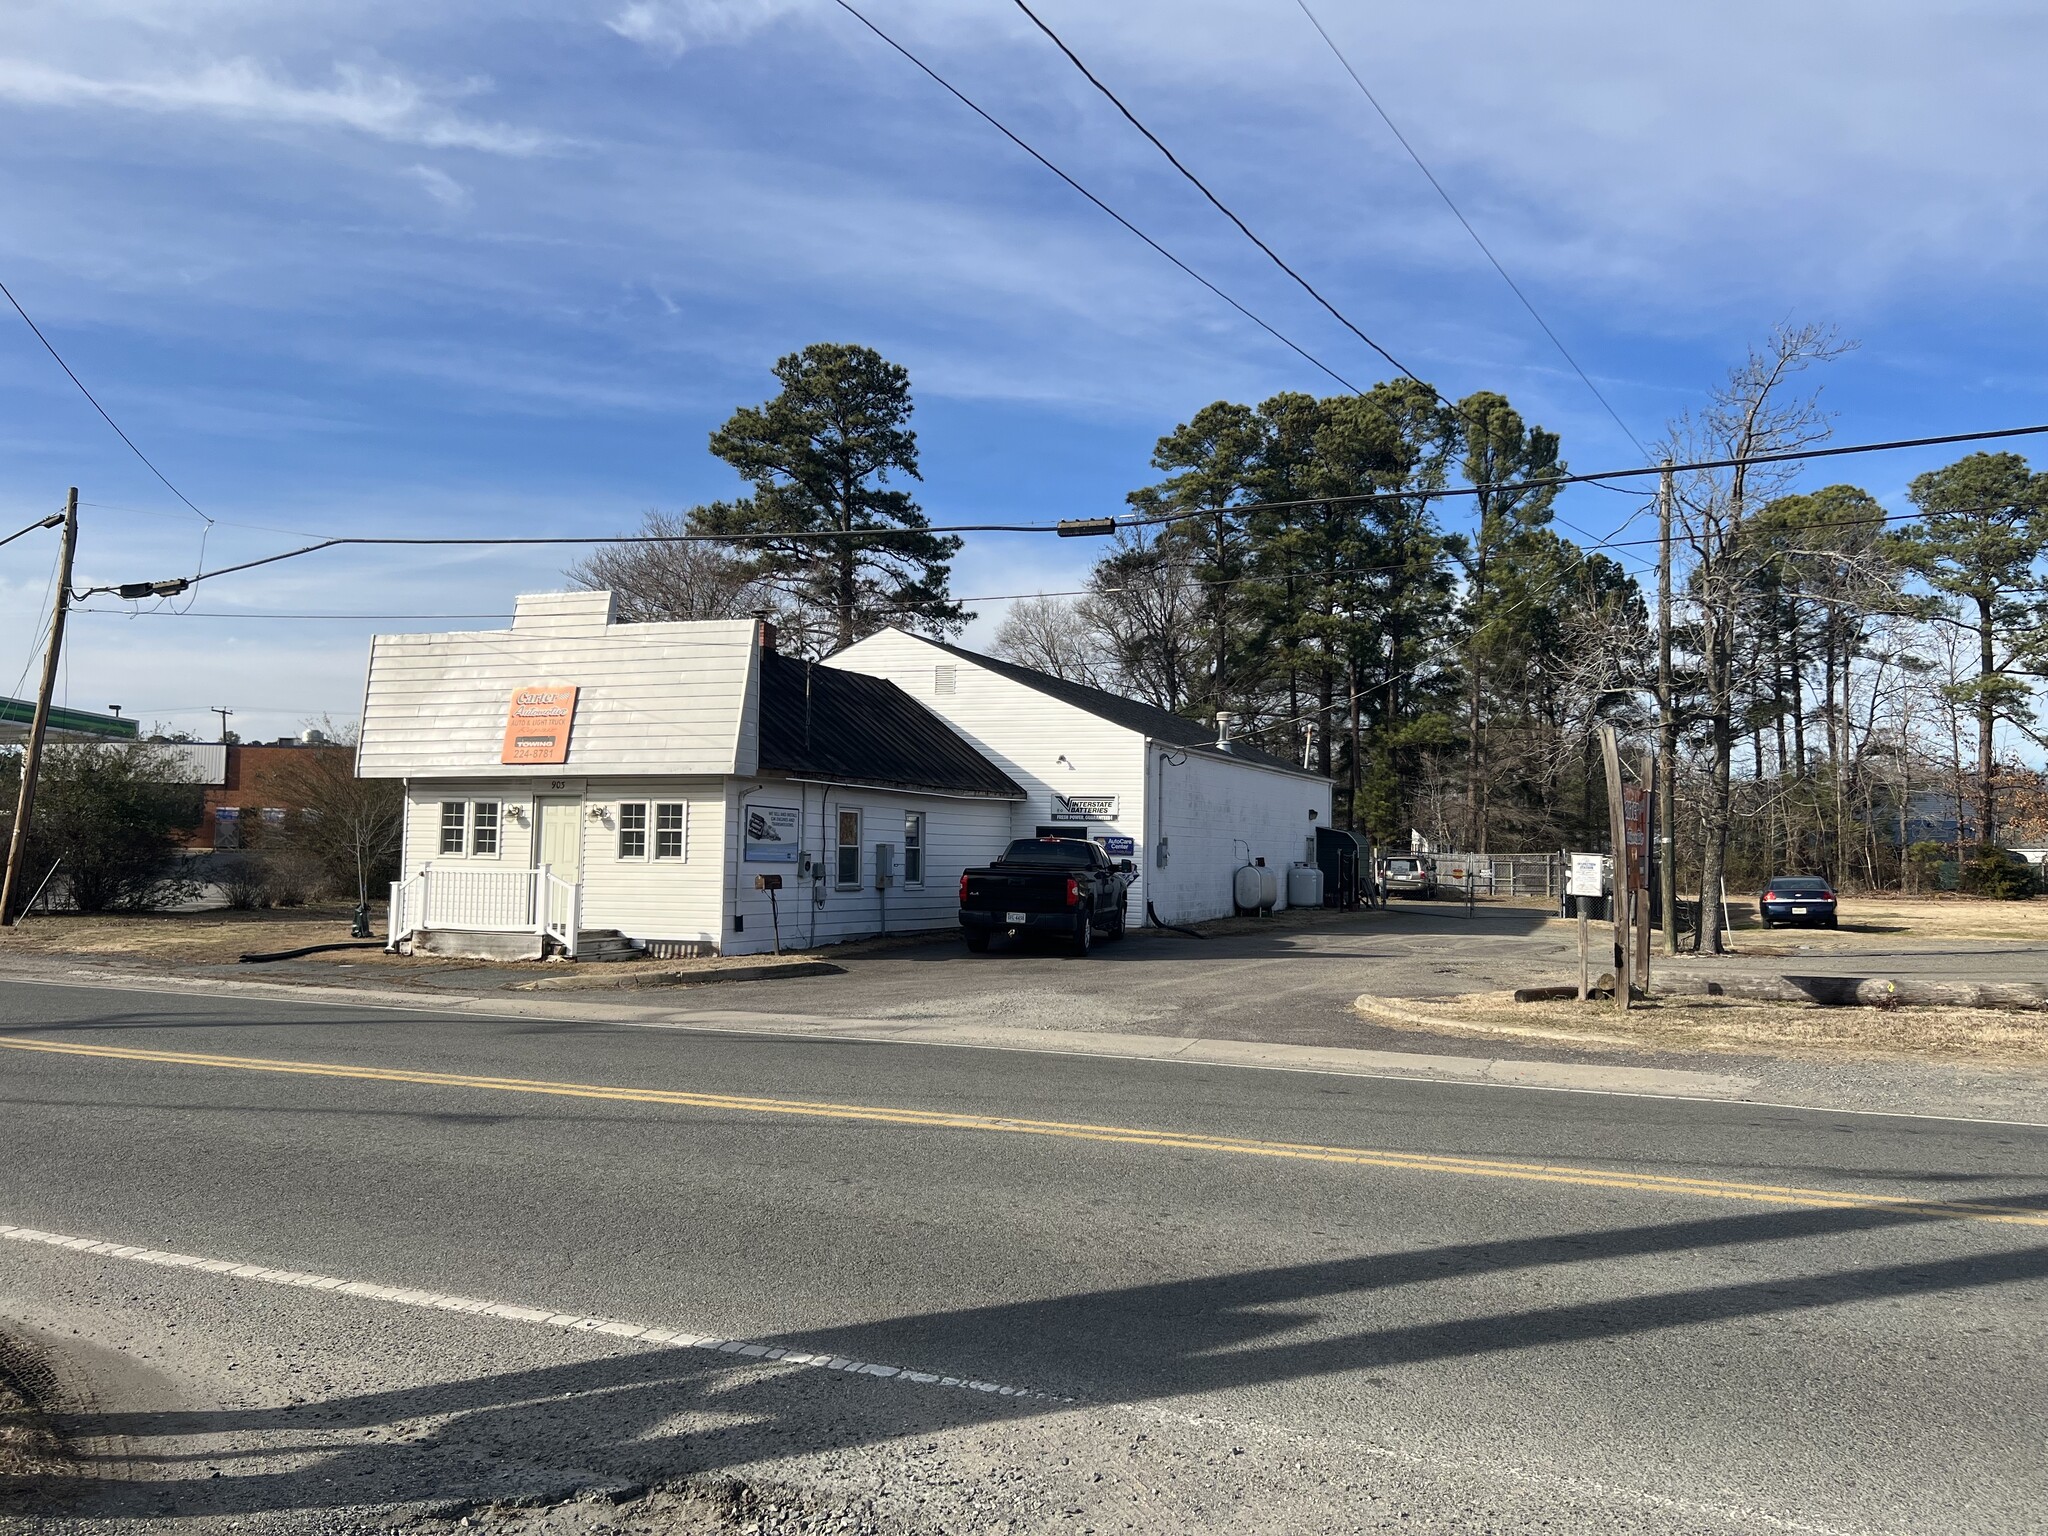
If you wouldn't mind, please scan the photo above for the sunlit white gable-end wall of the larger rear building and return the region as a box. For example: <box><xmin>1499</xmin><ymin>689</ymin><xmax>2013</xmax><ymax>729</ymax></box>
<box><xmin>825</xmin><ymin>629</ymin><xmax>1151</xmax><ymax>922</ymax></box>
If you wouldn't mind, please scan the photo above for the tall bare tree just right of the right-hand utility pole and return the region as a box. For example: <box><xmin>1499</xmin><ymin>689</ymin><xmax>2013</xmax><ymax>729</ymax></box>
<box><xmin>1669</xmin><ymin>324</ymin><xmax>1849</xmax><ymax>954</ymax></box>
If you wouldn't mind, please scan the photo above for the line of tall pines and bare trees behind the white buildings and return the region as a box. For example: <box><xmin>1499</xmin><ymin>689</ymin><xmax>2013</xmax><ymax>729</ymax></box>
<box><xmin>569</xmin><ymin>337</ymin><xmax>2048</xmax><ymax>946</ymax></box>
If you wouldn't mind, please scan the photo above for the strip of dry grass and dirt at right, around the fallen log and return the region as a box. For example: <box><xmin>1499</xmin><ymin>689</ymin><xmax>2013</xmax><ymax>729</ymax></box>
<box><xmin>1356</xmin><ymin>991</ymin><xmax>2048</xmax><ymax>1067</ymax></box>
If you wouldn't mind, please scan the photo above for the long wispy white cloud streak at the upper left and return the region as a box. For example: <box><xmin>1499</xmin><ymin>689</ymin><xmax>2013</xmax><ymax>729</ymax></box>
<box><xmin>0</xmin><ymin>57</ymin><xmax>559</xmax><ymax>156</ymax></box>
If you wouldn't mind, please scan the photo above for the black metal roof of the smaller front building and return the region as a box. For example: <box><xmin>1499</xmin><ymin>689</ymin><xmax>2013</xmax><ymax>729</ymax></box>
<box><xmin>760</xmin><ymin>651</ymin><xmax>1024</xmax><ymax>801</ymax></box>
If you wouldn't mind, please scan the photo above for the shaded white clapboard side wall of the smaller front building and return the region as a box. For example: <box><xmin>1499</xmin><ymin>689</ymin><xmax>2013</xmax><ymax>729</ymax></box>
<box><xmin>725</xmin><ymin>780</ymin><xmax>1012</xmax><ymax>954</ymax></box>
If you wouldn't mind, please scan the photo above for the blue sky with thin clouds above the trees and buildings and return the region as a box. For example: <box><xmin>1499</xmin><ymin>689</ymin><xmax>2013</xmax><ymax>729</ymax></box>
<box><xmin>0</xmin><ymin>0</ymin><xmax>2048</xmax><ymax>735</ymax></box>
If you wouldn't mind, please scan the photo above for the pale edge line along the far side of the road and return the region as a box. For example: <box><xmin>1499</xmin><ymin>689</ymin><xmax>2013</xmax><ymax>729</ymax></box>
<box><xmin>0</xmin><ymin>973</ymin><xmax>2048</xmax><ymax>1130</ymax></box>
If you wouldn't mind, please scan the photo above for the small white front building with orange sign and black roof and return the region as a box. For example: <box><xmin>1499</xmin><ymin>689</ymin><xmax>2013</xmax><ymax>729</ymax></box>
<box><xmin>356</xmin><ymin>592</ymin><xmax>1024</xmax><ymax>958</ymax></box>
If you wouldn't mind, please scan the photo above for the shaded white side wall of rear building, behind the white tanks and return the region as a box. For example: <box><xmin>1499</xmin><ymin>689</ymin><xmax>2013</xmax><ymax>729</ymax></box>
<box><xmin>1151</xmin><ymin>748</ymin><xmax>1331</xmax><ymax>924</ymax></box>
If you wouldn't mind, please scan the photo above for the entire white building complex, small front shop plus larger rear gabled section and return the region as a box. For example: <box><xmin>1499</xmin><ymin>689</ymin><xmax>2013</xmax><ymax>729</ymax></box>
<box><xmin>356</xmin><ymin>592</ymin><xmax>1331</xmax><ymax>958</ymax></box>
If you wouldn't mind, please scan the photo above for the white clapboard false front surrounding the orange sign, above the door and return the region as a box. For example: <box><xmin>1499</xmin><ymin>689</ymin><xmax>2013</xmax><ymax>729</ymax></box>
<box><xmin>356</xmin><ymin>614</ymin><xmax>760</xmax><ymax>780</ymax></box>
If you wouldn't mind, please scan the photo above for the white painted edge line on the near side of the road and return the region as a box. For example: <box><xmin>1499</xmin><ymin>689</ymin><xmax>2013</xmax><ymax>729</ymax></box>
<box><xmin>0</xmin><ymin>1223</ymin><xmax>1073</xmax><ymax>1403</ymax></box>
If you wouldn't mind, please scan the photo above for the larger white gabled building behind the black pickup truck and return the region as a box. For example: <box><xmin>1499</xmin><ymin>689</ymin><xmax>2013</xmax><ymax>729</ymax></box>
<box><xmin>825</xmin><ymin>629</ymin><xmax>1331</xmax><ymax>924</ymax></box>
